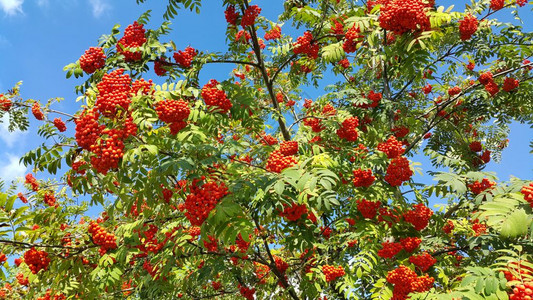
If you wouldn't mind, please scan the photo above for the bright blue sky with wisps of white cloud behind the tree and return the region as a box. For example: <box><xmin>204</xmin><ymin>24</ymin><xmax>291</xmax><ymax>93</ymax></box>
<box><xmin>0</xmin><ymin>0</ymin><xmax>533</xmax><ymax>192</ymax></box>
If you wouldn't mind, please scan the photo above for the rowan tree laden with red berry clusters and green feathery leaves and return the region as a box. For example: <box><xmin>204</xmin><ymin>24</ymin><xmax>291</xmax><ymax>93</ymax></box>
<box><xmin>0</xmin><ymin>0</ymin><xmax>533</xmax><ymax>299</ymax></box>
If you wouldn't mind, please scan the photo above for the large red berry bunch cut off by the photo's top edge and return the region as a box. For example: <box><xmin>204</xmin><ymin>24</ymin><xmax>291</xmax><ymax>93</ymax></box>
<box><xmin>379</xmin><ymin>0</ymin><xmax>431</xmax><ymax>35</ymax></box>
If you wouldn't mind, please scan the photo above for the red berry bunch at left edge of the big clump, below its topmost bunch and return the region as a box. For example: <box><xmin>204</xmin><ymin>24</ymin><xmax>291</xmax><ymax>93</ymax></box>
<box><xmin>74</xmin><ymin>108</ymin><xmax>105</xmax><ymax>150</ymax></box>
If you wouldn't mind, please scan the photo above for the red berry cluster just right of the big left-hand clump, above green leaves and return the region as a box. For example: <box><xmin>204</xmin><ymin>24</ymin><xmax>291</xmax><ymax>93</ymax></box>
<box><xmin>155</xmin><ymin>99</ymin><xmax>191</xmax><ymax>135</ymax></box>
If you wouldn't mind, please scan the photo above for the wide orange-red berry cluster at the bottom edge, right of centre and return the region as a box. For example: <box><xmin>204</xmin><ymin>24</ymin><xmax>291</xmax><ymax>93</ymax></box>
<box><xmin>387</xmin><ymin>265</ymin><xmax>435</xmax><ymax>300</ymax></box>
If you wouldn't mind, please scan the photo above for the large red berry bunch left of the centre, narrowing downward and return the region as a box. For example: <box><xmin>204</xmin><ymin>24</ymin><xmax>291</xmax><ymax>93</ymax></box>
<box><xmin>185</xmin><ymin>179</ymin><xmax>228</xmax><ymax>226</ymax></box>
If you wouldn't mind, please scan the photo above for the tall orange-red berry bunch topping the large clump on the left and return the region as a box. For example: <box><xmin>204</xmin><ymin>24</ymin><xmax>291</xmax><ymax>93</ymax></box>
<box><xmin>95</xmin><ymin>69</ymin><xmax>131</xmax><ymax>117</ymax></box>
